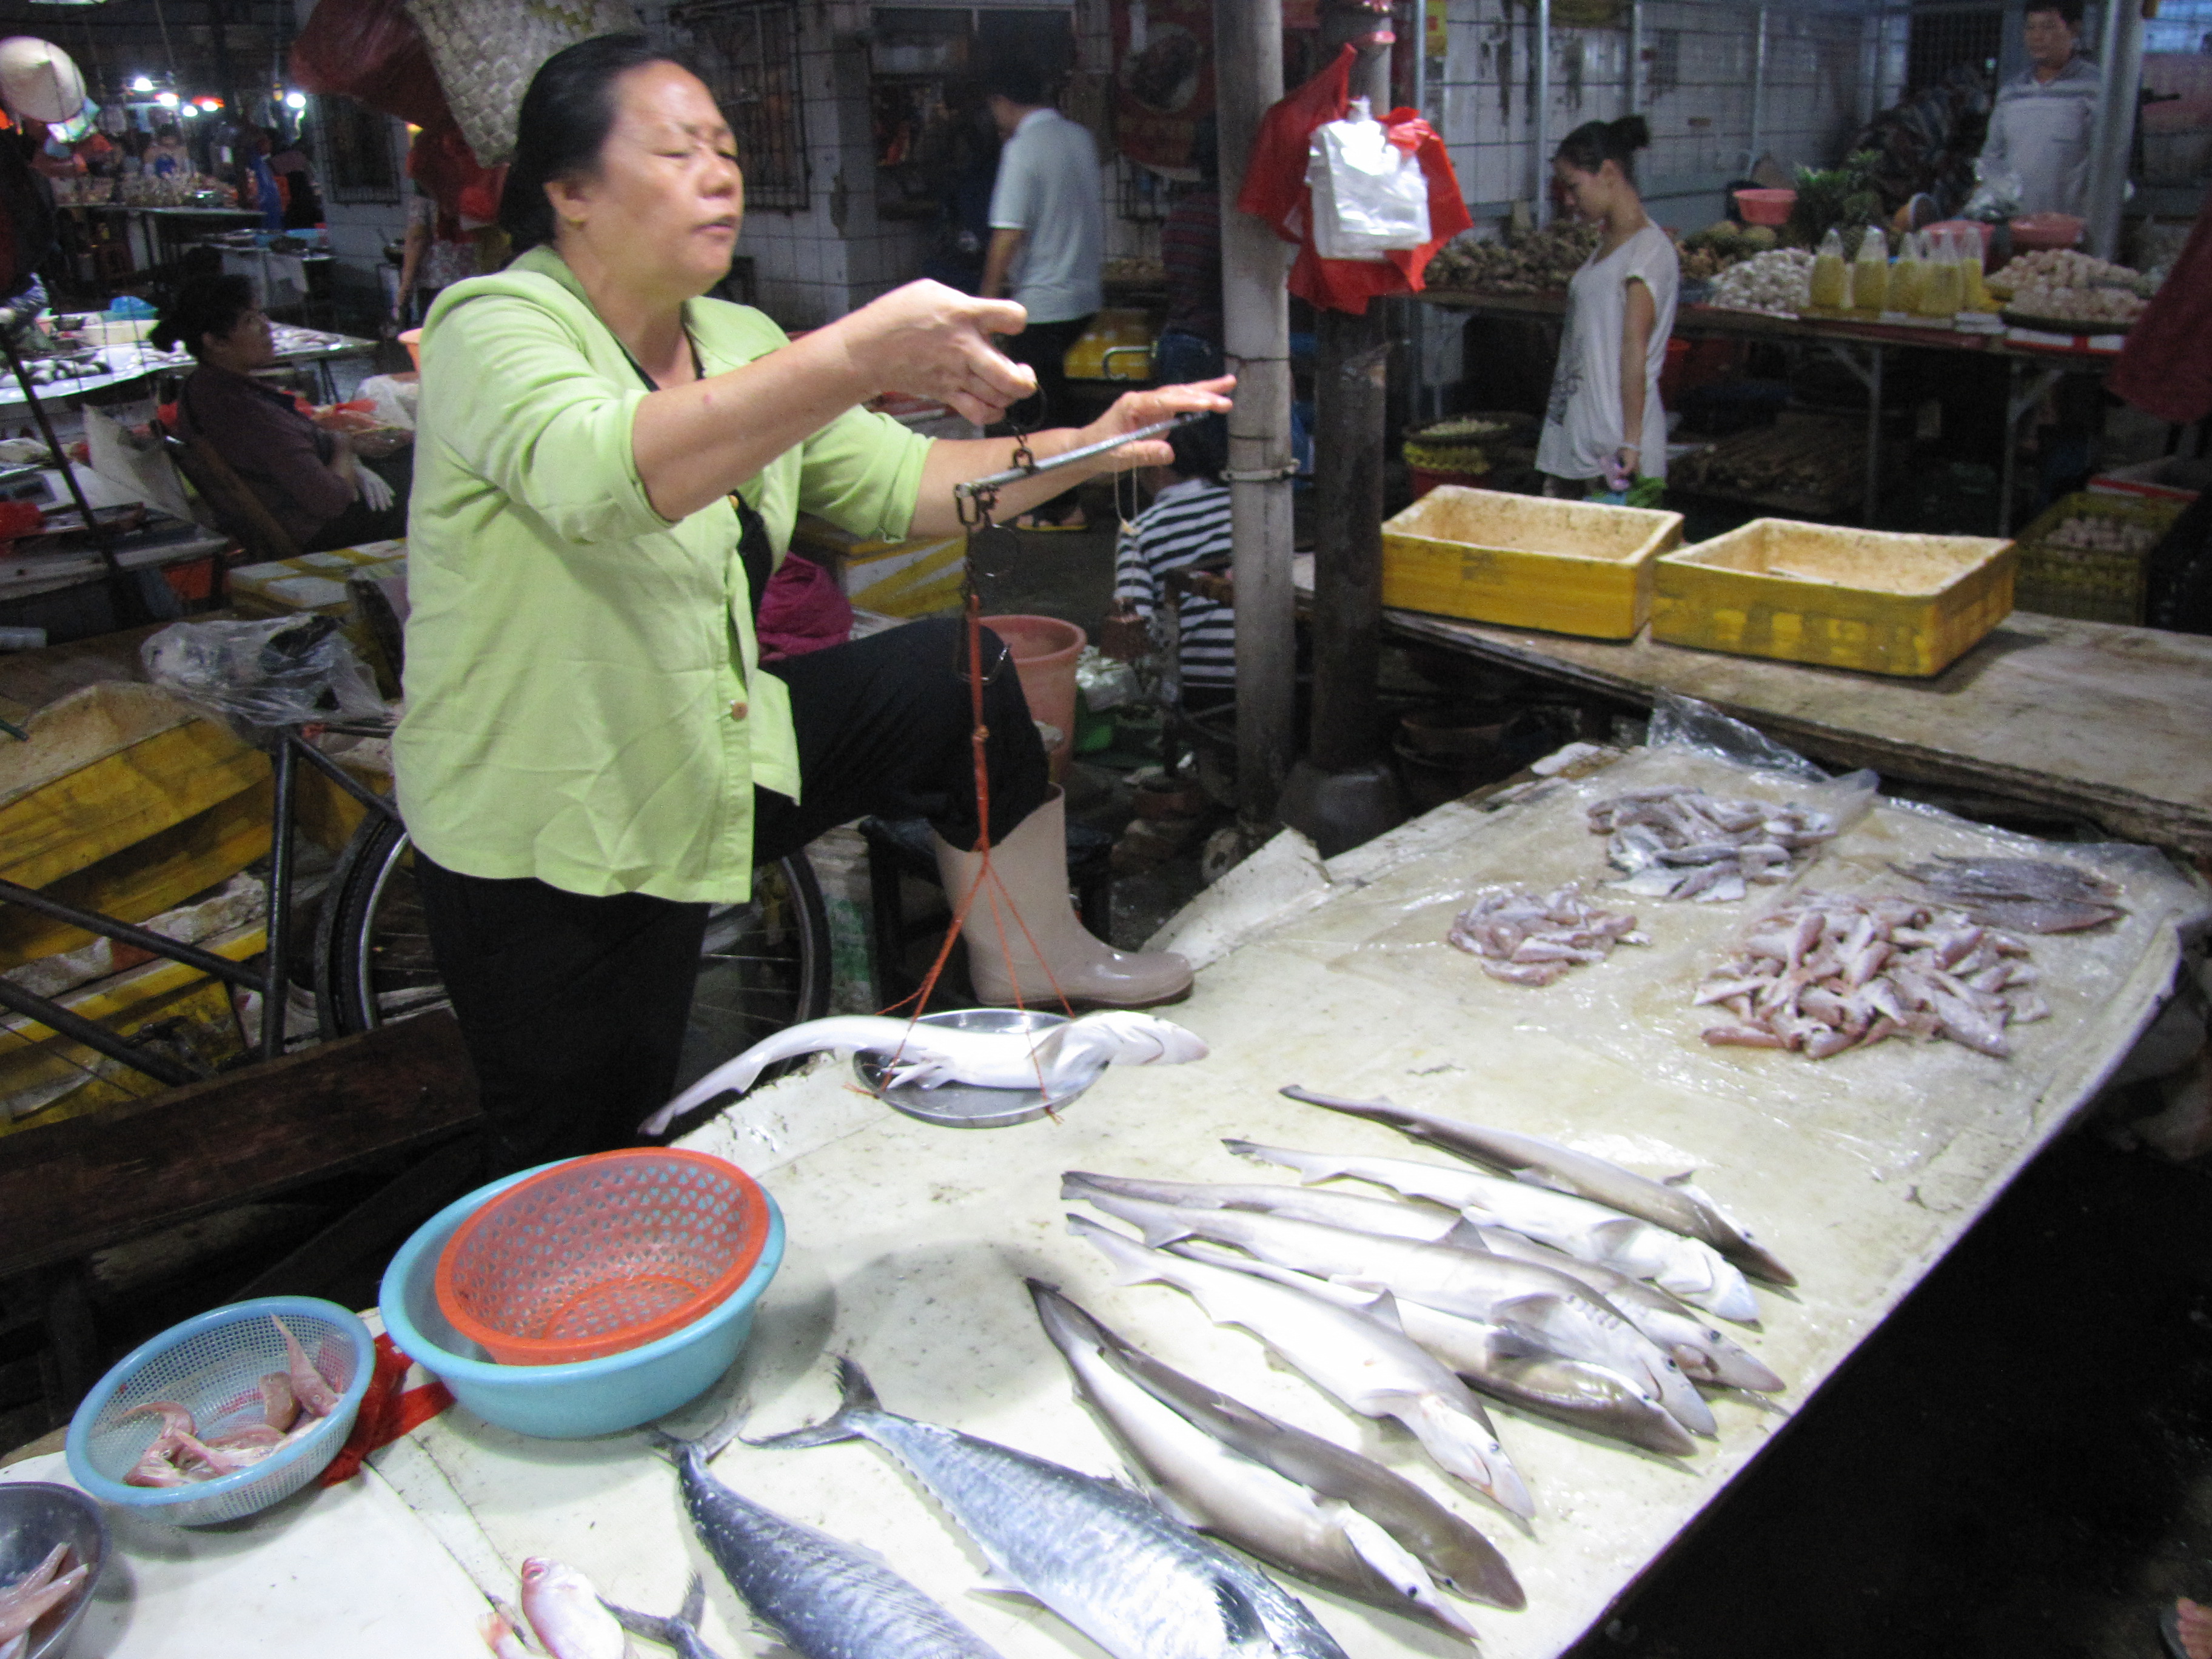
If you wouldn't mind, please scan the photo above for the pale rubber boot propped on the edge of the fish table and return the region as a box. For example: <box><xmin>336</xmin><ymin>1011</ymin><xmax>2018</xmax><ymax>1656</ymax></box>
<box><xmin>936</xmin><ymin>789</ymin><xmax>1190</xmax><ymax>1008</ymax></box>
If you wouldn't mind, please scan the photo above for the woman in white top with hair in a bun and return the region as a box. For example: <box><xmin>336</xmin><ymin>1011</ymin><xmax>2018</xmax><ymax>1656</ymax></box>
<box><xmin>1535</xmin><ymin>115</ymin><xmax>1681</xmax><ymax>506</ymax></box>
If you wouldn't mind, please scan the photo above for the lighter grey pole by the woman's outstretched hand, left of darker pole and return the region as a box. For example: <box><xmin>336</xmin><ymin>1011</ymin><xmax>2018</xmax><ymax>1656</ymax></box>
<box><xmin>1215</xmin><ymin>0</ymin><xmax>1298</xmax><ymax>832</ymax></box>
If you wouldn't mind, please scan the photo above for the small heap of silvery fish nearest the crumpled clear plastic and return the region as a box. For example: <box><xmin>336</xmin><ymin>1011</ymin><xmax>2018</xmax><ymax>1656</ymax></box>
<box><xmin>1588</xmin><ymin>783</ymin><xmax>1838</xmax><ymax>905</ymax></box>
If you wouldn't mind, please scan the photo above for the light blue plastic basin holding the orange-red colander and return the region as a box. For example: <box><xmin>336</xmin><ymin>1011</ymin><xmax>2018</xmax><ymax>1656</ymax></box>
<box><xmin>378</xmin><ymin>1164</ymin><xmax>783</xmax><ymax>1440</ymax></box>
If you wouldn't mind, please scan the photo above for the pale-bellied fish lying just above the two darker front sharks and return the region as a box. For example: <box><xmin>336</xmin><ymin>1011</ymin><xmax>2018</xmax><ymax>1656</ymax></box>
<box><xmin>1068</xmin><ymin>1199</ymin><xmax>1535</xmax><ymax>1518</ymax></box>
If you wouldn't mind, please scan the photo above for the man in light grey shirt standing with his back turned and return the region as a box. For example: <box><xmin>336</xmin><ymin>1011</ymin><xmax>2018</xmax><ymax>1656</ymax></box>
<box><xmin>982</xmin><ymin>53</ymin><xmax>1106</xmax><ymax>529</ymax></box>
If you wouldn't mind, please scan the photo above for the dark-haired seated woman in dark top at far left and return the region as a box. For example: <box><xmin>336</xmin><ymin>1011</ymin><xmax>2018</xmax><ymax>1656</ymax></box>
<box><xmin>150</xmin><ymin>276</ymin><xmax>407</xmax><ymax>553</ymax></box>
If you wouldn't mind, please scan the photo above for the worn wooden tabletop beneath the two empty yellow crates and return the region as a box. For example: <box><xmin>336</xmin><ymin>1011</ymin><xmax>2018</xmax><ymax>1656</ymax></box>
<box><xmin>1362</xmin><ymin>588</ymin><xmax>2212</xmax><ymax>860</ymax></box>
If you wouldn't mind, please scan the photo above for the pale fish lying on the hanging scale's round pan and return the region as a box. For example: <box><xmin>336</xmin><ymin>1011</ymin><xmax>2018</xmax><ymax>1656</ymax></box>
<box><xmin>637</xmin><ymin>1008</ymin><xmax>1205</xmax><ymax>1134</ymax></box>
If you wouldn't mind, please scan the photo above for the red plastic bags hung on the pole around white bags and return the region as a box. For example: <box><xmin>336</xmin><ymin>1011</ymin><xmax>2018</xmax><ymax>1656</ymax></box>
<box><xmin>1236</xmin><ymin>47</ymin><xmax>1475</xmax><ymax>317</ymax></box>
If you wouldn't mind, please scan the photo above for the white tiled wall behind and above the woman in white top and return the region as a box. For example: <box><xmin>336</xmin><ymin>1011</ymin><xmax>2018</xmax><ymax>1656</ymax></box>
<box><xmin>1429</xmin><ymin>0</ymin><xmax>1869</xmax><ymax>226</ymax></box>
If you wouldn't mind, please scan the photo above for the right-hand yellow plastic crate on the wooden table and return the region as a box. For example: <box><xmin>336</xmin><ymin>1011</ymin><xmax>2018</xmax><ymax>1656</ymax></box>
<box><xmin>1652</xmin><ymin>518</ymin><xmax>2020</xmax><ymax>677</ymax></box>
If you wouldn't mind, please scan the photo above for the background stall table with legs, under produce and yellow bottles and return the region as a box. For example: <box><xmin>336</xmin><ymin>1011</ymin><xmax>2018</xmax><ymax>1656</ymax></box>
<box><xmin>1420</xmin><ymin>287</ymin><xmax>2121</xmax><ymax>535</ymax></box>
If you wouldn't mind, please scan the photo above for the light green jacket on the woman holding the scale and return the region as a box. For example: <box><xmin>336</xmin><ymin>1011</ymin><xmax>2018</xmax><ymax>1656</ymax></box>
<box><xmin>394</xmin><ymin>248</ymin><xmax>929</xmax><ymax>902</ymax></box>
